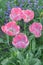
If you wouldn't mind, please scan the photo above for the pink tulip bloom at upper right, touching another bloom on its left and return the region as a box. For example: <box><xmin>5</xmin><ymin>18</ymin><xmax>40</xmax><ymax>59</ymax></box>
<box><xmin>22</xmin><ymin>9</ymin><xmax>34</xmax><ymax>23</ymax></box>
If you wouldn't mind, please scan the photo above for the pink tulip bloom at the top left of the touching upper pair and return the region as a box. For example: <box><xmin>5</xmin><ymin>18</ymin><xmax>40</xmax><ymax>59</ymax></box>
<box><xmin>10</xmin><ymin>8</ymin><xmax>22</xmax><ymax>21</ymax></box>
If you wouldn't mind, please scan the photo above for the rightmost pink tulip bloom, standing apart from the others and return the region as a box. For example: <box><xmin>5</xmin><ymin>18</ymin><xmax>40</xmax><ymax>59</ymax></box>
<box><xmin>29</xmin><ymin>22</ymin><xmax>42</xmax><ymax>37</ymax></box>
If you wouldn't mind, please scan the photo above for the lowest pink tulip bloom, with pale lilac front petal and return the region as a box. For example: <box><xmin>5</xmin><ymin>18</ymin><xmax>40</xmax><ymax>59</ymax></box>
<box><xmin>12</xmin><ymin>33</ymin><xmax>29</xmax><ymax>48</ymax></box>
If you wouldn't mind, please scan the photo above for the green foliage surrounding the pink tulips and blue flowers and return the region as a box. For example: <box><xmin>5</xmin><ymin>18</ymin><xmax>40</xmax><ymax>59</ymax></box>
<box><xmin>0</xmin><ymin>0</ymin><xmax>43</xmax><ymax>65</ymax></box>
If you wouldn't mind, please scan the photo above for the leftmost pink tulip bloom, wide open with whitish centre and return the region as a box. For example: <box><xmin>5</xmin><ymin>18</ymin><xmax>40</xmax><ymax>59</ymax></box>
<box><xmin>1</xmin><ymin>21</ymin><xmax>20</xmax><ymax>36</ymax></box>
